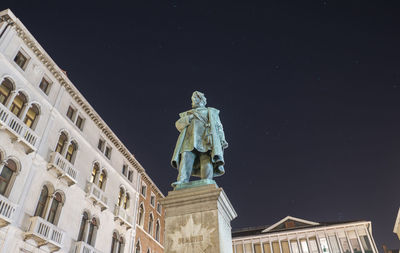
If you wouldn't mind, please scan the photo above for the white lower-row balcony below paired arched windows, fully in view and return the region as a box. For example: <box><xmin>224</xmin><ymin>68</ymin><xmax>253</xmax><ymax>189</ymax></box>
<box><xmin>25</xmin><ymin>216</ymin><xmax>65</xmax><ymax>252</ymax></box>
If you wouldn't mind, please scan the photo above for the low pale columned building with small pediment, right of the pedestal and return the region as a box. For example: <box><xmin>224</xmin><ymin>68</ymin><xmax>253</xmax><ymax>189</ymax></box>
<box><xmin>232</xmin><ymin>216</ymin><xmax>378</xmax><ymax>253</ymax></box>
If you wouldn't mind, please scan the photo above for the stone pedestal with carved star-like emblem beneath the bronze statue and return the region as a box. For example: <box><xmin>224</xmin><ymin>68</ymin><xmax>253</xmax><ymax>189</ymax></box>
<box><xmin>162</xmin><ymin>184</ymin><xmax>237</xmax><ymax>253</ymax></box>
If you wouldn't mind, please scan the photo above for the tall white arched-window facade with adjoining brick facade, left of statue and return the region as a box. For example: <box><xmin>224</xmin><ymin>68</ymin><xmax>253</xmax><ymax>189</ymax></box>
<box><xmin>0</xmin><ymin>10</ymin><xmax>164</xmax><ymax>253</ymax></box>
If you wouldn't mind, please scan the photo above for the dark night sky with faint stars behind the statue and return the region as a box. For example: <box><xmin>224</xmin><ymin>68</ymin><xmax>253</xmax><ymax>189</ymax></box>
<box><xmin>0</xmin><ymin>0</ymin><xmax>400</xmax><ymax>250</ymax></box>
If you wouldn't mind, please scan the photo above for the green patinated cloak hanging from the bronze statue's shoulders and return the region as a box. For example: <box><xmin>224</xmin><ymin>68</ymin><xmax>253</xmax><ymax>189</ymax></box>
<box><xmin>171</xmin><ymin>107</ymin><xmax>228</xmax><ymax>177</ymax></box>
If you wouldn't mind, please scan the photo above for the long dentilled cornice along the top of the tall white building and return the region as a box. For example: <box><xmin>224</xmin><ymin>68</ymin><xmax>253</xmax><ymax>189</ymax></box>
<box><xmin>0</xmin><ymin>9</ymin><xmax>164</xmax><ymax>196</ymax></box>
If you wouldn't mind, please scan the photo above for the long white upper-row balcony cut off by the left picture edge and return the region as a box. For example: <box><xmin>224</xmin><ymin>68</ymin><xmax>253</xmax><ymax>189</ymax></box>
<box><xmin>0</xmin><ymin>103</ymin><xmax>39</xmax><ymax>153</ymax></box>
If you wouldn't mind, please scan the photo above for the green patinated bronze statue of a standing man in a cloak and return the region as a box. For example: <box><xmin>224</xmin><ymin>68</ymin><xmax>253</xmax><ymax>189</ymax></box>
<box><xmin>171</xmin><ymin>91</ymin><xmax>228</xmax><ymax>187</ymax></box>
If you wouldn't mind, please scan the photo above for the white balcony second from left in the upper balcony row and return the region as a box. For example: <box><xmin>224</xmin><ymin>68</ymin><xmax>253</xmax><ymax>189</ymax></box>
<box><xmin>48</xmin><ymin>152</ymin><xmax>78</xmax><ymax>186</ymax></box>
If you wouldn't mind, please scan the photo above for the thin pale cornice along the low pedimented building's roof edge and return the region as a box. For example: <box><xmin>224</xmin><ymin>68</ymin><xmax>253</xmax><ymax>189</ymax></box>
<box><xmin>232</xmin><ymin>221</ymin><xmax>371</xmax><ymax>241</ymax></box>
